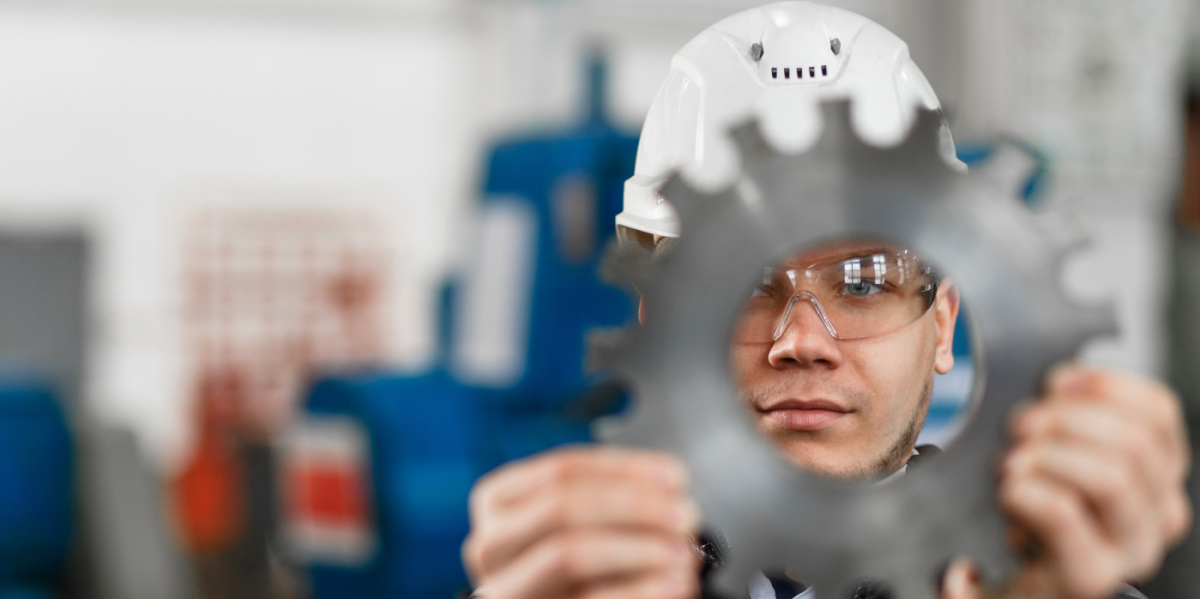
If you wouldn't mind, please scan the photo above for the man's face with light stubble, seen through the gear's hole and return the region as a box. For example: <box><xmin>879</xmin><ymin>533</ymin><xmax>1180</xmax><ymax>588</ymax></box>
<box><xmin>730</xmin><ymin>241</ymin><xmax>959</xmax><ymax>478</ymax></box>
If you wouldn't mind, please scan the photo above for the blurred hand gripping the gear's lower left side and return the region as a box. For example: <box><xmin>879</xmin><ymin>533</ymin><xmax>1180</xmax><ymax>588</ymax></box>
<box><xmin>462</xmin><ymin>447</ymin><xmax>701</xmax><ymax>599</ymax></box>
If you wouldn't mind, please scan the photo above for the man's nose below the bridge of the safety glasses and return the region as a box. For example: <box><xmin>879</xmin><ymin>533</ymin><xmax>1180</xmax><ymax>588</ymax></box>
<box><xmin>767</xmin><ymin>293</ymin><xmax>842</xmax><ymax>369</ymax></box>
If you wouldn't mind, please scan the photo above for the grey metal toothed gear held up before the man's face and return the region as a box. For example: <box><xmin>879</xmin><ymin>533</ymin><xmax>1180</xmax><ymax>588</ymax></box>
<box><xmin>592</xmin><ymin>102</ymin><xmax>1115</xmax><ymax>599</ymax></box>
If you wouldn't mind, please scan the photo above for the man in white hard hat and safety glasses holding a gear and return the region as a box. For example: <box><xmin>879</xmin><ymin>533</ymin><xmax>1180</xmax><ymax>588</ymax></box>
<box><xmin>463</xmin><ymin>2</ymin><xmax>1190</xmax><ymax>599</ymax></box>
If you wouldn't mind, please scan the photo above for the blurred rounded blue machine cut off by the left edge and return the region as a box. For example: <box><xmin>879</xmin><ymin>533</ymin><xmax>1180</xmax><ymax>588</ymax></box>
<box><xmin>0</xmin><ymin>381</ymin><xmax>76</xmax><ymax>599</ymax></box>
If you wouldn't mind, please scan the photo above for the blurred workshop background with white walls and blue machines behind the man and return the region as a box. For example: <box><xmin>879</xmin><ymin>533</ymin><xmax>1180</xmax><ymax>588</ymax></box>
<box><xmin>0</xmin><ymin>0</ymin><xmax>1200</xmax><ymax>599</ymax></box>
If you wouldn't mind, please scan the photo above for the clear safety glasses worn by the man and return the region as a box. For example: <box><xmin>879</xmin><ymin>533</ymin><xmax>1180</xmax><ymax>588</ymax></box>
<box><xmin>734</xmin><ymin>246</ymin><xmax>936</xmax><ymax>343</ymax></box>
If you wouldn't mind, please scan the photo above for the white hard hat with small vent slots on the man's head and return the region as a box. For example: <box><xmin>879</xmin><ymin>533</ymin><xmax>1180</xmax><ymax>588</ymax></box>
<box><xmin>617</xmin><ymin>1</ymin><xmax>965</xmax><ymax>238</ymax></box>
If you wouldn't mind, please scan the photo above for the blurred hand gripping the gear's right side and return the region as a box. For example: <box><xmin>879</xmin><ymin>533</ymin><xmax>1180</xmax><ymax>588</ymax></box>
<box><xmin>943</xmin><ymin>367</ymin><xmax>1192</xmax><ymax>599</ymax></box>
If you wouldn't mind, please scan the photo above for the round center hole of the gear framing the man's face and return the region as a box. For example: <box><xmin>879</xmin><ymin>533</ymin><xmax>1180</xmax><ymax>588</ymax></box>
<box><xmin>728</xmin><ymin>239</ymin><xmax>976</xmax><ymax>480</ymax></box>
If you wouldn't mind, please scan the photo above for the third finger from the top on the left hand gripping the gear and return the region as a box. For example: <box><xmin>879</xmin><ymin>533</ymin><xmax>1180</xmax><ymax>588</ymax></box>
<box><xmin>486</xmin><ymin>529</ymin><xmax>700</xmax><ymax>599</ymax></box>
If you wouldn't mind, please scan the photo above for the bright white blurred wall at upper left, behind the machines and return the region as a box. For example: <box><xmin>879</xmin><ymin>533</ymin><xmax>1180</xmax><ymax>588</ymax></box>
<box><xmin>0</xmin><ymin>7</ymin><xmax>485</xmax><ymax>462</ymax></box>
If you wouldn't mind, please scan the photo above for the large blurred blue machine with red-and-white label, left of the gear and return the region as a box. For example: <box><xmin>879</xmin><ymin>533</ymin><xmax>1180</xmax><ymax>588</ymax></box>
<box><xmin>280</xmin><ymin>58</ymin><xmax>637</xmax><ymax>599</ymax></box>
